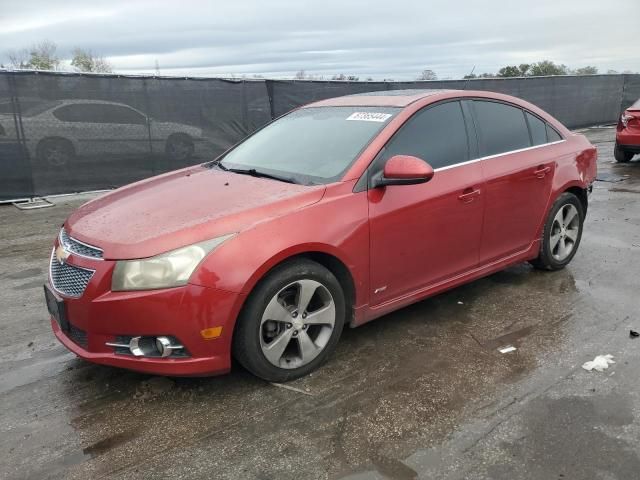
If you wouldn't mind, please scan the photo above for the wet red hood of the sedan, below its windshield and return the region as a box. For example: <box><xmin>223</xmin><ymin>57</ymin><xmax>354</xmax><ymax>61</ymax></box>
<box><xmin>65</xmin><ymin>166</ymin><xmax>325</xmax><ymax>260</ymax></box>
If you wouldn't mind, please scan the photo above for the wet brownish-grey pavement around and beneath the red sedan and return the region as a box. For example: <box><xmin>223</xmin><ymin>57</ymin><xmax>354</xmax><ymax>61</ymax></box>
<box><xmin>0</xmin><ymin>128</ymin><xmax>640</xmax><ymax>480</ymax></box>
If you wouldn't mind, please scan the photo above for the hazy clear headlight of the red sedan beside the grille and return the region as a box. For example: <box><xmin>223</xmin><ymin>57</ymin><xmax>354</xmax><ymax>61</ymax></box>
<box><xmin>111</xmin><ymin>234</ymin><xmax>234</xmax><ymax>292</ymax></box>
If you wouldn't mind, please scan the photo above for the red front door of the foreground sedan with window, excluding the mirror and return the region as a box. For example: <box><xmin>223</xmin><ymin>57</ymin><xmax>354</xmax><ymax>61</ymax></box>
<box><xmin>368</xmin><ymin>100</ymin><xmax>483</xmax><ymax>305</ymax></box>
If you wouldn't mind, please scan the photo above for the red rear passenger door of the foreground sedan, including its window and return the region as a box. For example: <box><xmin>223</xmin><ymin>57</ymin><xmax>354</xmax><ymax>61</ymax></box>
<box><xmin>472</xmin><ymin>100</ymin><xmax>560</xmax><ymax>265</ymax></box>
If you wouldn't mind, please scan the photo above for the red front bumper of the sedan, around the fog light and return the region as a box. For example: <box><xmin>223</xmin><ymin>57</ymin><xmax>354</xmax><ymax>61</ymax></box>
<box><xmin>49</xmin><ymin>244</ymin><xmax>244</xmax><ymax>376</ymax></box>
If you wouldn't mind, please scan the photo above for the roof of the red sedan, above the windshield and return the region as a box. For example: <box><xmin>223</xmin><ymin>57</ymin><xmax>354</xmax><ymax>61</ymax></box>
<box><xmin>305</xmin><ymin>89</ymin><xmax>456</xmax><ymax>107</ymax></box>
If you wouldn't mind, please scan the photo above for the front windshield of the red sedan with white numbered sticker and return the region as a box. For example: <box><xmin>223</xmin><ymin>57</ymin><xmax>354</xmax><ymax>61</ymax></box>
<box><xmin>220</xmin><ymin>107</ymin><xmax>399</xmax><ymax>184</ymax></box>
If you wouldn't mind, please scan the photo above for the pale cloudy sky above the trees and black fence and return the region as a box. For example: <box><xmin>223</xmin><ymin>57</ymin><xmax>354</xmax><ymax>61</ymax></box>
<box><xmin>0</xmin><ymin>0</ymin><xmax>640</xmax><ymax>80</ymax></box>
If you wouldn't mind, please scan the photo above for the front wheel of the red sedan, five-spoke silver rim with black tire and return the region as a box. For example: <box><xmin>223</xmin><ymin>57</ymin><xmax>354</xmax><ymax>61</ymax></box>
<box><xmin>233</xmin><ymin>259</ymin><xmax>346</xmax><ymax>382</ymax></box>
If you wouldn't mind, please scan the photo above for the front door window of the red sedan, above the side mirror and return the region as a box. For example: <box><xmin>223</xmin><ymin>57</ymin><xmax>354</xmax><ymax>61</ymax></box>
<box><xmin>377</xmin><ymin>101</ymin><xmax>469</xmax><ymax>169</ymax></box>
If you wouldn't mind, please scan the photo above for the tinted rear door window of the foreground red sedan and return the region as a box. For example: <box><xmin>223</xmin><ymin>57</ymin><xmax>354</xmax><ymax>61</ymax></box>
<box><xmin>473</xmin><ymin>100</ymin><xmax>531</xmax><ymax>157</ymax></box>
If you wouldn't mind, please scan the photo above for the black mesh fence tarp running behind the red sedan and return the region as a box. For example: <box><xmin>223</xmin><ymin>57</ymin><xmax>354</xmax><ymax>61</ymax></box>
<box><xmin>0</xmin><ymin>72</ymin><xmax>640</xmax><ymax>201</ymax></box>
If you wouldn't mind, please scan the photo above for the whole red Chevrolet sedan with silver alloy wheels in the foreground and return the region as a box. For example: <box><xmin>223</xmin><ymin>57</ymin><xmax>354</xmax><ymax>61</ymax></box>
<box><xmin>45</xmin><ymin>90</ymin><xmax>596</xmax><ymax>381</ymax></box>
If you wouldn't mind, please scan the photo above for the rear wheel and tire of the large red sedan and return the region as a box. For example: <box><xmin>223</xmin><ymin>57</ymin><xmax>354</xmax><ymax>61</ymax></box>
<box><xmin>530</xmin><ymin>192</ymin><xmax>584</xmax><ymax>270</ymax></box>
